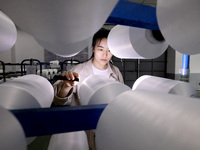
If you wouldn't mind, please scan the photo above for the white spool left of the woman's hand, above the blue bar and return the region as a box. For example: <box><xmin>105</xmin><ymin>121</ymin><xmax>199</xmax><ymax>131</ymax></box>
<box><xmin>0</xmin><ymin>74</ymin><xmax>54</xmax><ymax>109</ymax></box>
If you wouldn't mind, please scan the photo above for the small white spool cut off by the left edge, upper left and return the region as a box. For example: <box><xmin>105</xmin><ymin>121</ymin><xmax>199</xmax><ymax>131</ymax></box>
<box><xmin>0</xmin><ymin>11</ymin><xmax>17</xmax><ymax>52</ymax></box>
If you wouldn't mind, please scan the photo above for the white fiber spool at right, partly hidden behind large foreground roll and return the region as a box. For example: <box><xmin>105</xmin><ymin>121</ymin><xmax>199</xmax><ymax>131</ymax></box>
<box><xmin>132</xmin><ymin>75</ymin><xmax>197</xmax><ymax>97</ymax></box>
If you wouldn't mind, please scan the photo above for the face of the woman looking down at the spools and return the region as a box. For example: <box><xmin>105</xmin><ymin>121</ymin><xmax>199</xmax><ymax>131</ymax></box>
<box><xmin>93</xmin><ymin>38</ymin><xmax>112</xmax><ymax>69</ymax></box>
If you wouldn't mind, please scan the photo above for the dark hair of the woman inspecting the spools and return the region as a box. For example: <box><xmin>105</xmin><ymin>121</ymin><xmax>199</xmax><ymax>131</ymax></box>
<box><xmin>92</xmin><ymin>28</ymin><xmax>110</xmax><ymax>48</ymax></box>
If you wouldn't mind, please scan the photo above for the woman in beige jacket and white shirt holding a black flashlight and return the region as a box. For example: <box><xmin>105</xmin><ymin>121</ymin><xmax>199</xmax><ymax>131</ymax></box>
<box><xmin>53</xmin><ymin>29</ymin><xmax>124</xmax><ymax>106</ymax></box>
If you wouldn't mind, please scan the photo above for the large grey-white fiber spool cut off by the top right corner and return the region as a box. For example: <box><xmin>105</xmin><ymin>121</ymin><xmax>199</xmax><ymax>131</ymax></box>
<box><xmin>156</xmin><ymin>0</ymin><xmax>200</xmax><ymax>55</ymax></box>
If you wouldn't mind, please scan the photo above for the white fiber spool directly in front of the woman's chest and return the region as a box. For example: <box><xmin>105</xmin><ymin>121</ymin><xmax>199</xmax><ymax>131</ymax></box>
<box><xmin>79</xmin><ymin>75</ymin><xmax>131</xmax><ymax>105</ymax></box>
